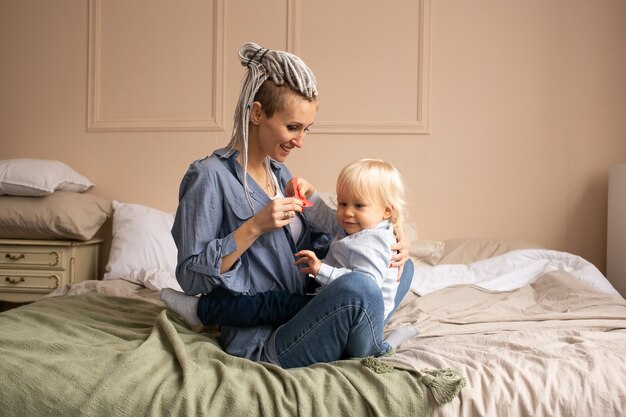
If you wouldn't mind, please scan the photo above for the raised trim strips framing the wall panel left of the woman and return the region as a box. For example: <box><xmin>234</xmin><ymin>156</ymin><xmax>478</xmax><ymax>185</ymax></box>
<box><xmin>87</xmin><ymin>0</ymin><xmax>225</xmax><ymax>132</ymax></box>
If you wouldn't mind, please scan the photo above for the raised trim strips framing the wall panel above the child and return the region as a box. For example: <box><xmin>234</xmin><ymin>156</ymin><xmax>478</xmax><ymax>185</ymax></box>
<box><xmin>287</xmin><ymin>0</ymin><xmax>431</xmax><ymax>135</ymax></box>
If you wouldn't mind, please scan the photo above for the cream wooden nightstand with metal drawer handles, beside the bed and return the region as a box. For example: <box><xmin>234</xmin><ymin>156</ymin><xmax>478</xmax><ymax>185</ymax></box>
<box><xmin>0</xmin><ymin>239</ymin><xmax>102</xmax><ymax>303</ymax></box>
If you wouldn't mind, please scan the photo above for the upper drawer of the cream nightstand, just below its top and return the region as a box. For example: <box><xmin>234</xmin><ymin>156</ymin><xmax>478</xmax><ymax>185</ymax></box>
<box><xmin>0</xmin><ymin>246</ymin><xmax>66</xmax><ymax>270</ymax></box>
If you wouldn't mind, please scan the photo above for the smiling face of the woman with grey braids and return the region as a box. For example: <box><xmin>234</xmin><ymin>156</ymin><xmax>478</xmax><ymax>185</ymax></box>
<box><xmin>250</xmin><ymin>95</ymin><xmax>317</xmax><ymax>162</ymax></box>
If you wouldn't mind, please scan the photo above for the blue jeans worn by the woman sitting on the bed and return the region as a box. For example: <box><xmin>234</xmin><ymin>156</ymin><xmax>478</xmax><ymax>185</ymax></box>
<box><xmin>266</xmin><ymin>261</ymin><xmax>413</xmax><ymax>368</ymax></box>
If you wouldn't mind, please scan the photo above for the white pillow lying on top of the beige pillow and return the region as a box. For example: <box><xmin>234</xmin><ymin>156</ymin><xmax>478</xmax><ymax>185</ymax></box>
<box><xmin>0</xmin><ymin>158</ymin><xmax>93</xmax><ymax>197</ymax></box>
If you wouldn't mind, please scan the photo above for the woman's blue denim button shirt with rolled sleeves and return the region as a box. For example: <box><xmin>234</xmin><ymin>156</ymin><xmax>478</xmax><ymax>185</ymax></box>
<box><xmin>172</xmin><ymin>149</ymin><xmax>320</xmax><ymax>360</ymax></box>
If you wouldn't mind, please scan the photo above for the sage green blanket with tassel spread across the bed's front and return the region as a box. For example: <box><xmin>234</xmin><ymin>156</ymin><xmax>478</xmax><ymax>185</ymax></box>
<box><xmin>0</xmin><ymin>293</ymin><xmax>458</xmax><ymax>417</ymax></box>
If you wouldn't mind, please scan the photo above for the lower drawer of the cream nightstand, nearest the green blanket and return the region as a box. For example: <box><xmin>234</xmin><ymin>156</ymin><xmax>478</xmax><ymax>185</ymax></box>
<box><xmin>0</xmin><ymin>270</ymin><xmax>67</xmax><ymax>294</ymax></box>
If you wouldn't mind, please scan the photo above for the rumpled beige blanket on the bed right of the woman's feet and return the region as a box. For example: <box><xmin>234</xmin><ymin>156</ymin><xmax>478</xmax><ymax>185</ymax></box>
<box><xmin>386</xmin><ymin>271</ymin><xmax>626</xmax><ymax>417</ymax></box>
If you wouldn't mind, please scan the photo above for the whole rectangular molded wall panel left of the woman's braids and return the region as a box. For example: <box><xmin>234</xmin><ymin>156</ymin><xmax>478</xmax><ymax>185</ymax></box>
<box><xmin>87</xmin><ymin>0</ymin><xmax>225</xmax><ymax>132</ymax></box>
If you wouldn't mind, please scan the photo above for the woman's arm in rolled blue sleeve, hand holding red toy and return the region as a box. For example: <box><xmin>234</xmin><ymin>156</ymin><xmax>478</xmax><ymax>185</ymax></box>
<box><xmin>172</xmin><ymin>157</ymin><xmax>302</xmax><ymax>295</ymax></box>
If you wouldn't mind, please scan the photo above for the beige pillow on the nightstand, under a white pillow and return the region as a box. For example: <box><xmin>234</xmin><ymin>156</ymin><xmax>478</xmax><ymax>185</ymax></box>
<box><xmin>0</xmin><ymin>191</ymin><xmax>111</xmax><ymax>240</ymax></box>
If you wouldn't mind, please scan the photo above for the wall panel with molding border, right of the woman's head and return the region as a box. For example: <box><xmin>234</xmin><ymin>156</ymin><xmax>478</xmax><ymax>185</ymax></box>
<box><xmin>287</xmin><ymin>0</ymin><xmax>431</xmax><ymax>135</ymax></box>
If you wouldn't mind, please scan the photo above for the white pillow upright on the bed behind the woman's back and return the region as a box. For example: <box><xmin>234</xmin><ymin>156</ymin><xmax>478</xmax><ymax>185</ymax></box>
<box><xmin>104</xmin><ymin>201</ymin><xmax>182</xmax><ymax>291</ymax></box>
